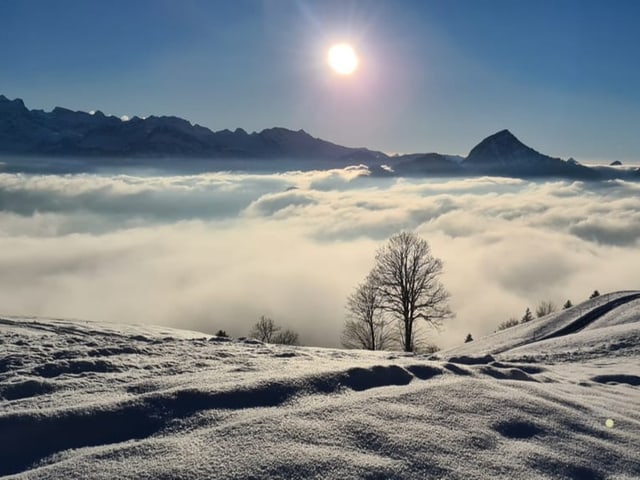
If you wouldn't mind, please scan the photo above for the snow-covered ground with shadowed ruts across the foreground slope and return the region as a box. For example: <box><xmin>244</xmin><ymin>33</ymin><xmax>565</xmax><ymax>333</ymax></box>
<box><xmin>0</xmin><ymin>292</ymin><xmax>640</xmax><ymax>479</ymax></box>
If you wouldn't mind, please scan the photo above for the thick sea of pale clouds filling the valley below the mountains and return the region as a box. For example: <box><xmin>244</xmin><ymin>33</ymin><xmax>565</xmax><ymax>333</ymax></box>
<box><xmin>0</xmin><ymin>167</ymin><xmax>640</xmax><ymax>347</ymax></box>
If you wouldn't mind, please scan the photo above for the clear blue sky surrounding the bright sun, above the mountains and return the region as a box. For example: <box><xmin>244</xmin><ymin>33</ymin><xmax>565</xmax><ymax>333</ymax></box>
<box><xmin>0</xmin><ymin>0</ymin><xmax>640</xmax><ymax>161</ymax></box>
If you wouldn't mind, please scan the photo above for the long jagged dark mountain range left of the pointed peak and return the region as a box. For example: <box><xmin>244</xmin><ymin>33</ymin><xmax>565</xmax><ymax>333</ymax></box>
<box><xmin>0</xmin><ymin>95</ymin><xmax>387</xmax><ymax>162</ymax></box>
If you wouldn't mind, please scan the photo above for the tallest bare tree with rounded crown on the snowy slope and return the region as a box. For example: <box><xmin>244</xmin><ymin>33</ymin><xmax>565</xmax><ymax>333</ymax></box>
<box><xmin>371</xmin><ymin>232</ymin><xmax>453</xmax><ymax>352</ymax></box>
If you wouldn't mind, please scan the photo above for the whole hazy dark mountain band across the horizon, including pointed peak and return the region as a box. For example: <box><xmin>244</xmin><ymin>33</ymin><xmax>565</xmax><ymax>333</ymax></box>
<box><xmin>0</xmin><ymin>95</ymin><xmax>640</xmax><ymax>180</ymax></box>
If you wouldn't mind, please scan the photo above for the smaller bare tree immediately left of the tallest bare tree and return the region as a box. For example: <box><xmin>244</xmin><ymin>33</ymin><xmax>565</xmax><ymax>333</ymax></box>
<box><xmin>342</xmin><ymin>276</ymin><xmax>392</xmax><ymax>350</ymax></box>
